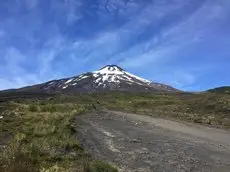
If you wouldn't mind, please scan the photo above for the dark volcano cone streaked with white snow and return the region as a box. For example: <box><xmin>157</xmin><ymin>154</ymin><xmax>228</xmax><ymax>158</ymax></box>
<box><xmin>18</xmin><ymin>65</ymin><xmax>177</xmax><ymax>93</ymax></box>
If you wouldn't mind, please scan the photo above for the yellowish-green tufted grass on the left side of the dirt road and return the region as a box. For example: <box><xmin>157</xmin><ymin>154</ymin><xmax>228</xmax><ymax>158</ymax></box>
<box><xmin>0</xmin><ymin>101</ymin><xmax>117</xmax><ymax>172</ymax></box>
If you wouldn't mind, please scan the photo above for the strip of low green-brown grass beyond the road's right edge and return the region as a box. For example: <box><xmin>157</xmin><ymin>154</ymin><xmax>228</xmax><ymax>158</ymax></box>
<box><xmin>89</xmin><ymin>93</ymin><xmax>230</xmax><ymax>128</ymax></box>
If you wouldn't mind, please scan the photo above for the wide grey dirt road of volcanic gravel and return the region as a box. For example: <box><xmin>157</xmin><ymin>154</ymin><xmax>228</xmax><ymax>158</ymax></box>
<box><xmin>76</xmin><ymin>112</ymin><xmax>230</xmax><ymax>172</ymax></box>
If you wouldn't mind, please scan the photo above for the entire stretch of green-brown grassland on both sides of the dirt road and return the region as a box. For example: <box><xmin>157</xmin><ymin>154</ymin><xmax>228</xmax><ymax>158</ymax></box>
<box><xmin>0</xmin><ymin>92</ymin><xmax>230</xmax><ymax>172</ymax></box>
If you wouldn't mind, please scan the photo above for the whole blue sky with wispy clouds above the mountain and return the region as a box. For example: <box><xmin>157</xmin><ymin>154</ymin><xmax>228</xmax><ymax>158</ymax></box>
<box><xmin>0</xmin><ymin>0</ymin><xmax>230</xmax><ymax>91</ymax></box>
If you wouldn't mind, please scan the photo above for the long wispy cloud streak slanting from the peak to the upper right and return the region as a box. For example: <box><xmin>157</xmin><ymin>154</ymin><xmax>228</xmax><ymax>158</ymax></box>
<box><xmin>116</xmin><ymin>0</ymin><xmax>230</xmax><ymax>72</ymax></box>
